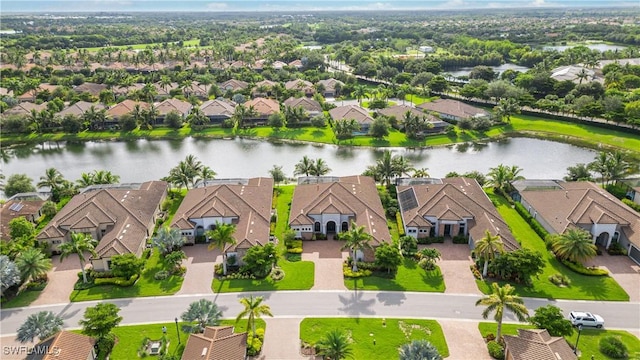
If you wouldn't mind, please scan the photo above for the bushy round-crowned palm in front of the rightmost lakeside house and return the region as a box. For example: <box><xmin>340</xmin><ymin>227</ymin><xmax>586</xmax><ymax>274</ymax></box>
<box><xmin>551</xmin><ymin>228</ymin><xmax>597</xmax><ymax>262</ymax></box>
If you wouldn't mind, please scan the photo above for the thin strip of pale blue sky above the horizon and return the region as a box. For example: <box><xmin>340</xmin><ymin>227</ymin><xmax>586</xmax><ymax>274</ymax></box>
<box><xmin>0</xmin><ymin>0</ymin><xmax>640</xmax><ymax>12</ymax></box>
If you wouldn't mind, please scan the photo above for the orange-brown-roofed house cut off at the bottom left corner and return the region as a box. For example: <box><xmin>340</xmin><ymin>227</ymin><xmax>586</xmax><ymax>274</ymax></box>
<box><xmin>25</xmin><ymin>330</ymin><xmax>98</xmax><ymax>360</ymax></box>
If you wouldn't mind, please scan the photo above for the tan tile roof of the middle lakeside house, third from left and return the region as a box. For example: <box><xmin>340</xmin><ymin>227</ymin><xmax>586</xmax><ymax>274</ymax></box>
<box><xmin>289</xmin><ymin>175</ymin><xmax>391</xmax><ymax>246</ymax></box>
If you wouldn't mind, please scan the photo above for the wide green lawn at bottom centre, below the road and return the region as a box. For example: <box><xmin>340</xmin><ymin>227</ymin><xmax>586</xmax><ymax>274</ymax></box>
<box><xmin>300</xmin><ymin>318</ymin><xmax>449</xmax><ymax>359</ymax></box>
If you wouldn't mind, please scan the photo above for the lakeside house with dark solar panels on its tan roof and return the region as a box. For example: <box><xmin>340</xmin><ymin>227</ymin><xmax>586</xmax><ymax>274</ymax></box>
<box><xmin>397</xmin><ymin>177</ymin><xmax>520</xmax><ymax>251</ymax></box>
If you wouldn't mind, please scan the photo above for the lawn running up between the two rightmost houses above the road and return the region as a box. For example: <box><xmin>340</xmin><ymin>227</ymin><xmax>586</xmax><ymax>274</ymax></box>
<box><xmin>476</xmin><ymin>190</ymin><xmax>629</xmax><ymax>301</ymax></box>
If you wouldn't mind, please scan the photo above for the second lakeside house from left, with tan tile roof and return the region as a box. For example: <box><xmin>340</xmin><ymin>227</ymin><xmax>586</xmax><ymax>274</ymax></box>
<box><xmin>171</xmin><ymin>178</ymin><xmax>273</xmax><ymax>262</ymax></box>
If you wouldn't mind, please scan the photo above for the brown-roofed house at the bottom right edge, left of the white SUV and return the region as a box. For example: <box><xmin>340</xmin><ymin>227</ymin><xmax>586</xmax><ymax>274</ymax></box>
<box><xmin>503</xmin><ymin>329</ymin><xmax>578</xmax><ymax>360</ymax></box>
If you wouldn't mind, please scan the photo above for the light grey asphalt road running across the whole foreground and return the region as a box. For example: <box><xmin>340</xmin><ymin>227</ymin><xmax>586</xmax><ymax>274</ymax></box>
<box><xmin>0</xmin><ymin>290</ymin><xmax>640</xmax><ymax>336</ymax></box>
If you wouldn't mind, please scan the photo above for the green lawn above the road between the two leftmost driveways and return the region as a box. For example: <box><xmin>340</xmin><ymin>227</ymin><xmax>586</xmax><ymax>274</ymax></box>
<box><xmin>70</xmin><ymin>251</ymin><xmax>184</xmax><ymax>302</ymax></box>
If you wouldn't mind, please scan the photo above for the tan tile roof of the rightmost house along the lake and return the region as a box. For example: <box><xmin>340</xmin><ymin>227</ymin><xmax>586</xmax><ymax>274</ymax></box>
<box><xmin>514</xmin><ymin>180</ymin><xmax>640</xmax><ymax>247</ymax></box>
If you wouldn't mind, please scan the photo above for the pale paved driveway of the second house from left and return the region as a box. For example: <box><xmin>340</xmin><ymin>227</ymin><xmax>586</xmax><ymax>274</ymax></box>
<box><xmin>177</xmin><ymin>244</ymin><xmax>222</xmax><ymax>295</ymax></box>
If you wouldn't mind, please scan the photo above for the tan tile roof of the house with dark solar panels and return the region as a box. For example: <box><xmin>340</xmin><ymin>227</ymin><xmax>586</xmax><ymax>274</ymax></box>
<box><xmin>398</xmin><ymin>177</ymin><xmax>520</xmax><ymax>251</ymax></box>
